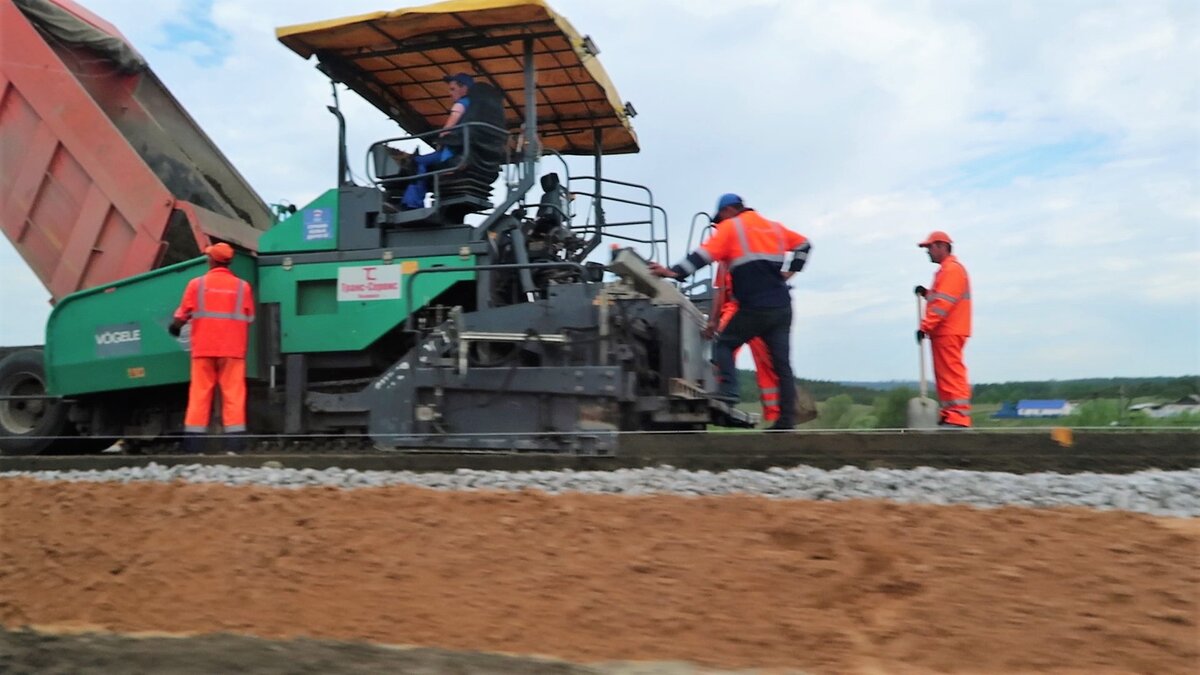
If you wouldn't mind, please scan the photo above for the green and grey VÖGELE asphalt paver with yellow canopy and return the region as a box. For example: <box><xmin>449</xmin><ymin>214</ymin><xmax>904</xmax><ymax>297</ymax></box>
<box><xmin>0</xmin><ymin>0</ymin><xmax>750</xmax><ymax>453</ymax></box>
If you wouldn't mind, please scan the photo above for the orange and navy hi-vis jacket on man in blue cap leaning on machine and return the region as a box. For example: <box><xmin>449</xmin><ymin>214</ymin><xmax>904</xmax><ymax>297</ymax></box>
<box><xmin>671</xmin><ymin>209</ymin><xmax>812</xmax><ymax>309</ymax></box>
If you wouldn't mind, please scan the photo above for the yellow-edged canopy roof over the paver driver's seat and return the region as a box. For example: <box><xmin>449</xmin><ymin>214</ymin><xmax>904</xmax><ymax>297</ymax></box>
<box><xmin>275</xmin><ymin>0</ymin><xmax>638</xmax><ymax>155</ymax></box>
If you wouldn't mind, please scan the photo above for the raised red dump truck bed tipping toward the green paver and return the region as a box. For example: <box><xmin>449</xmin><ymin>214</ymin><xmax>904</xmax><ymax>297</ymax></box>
<box><xmin>0</xmin><ymin>0</ymin><xmax>271</xmax><ymax>300</ymax></box>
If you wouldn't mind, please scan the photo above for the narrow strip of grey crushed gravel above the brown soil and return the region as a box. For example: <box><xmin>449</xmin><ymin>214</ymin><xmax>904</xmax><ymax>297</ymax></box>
<box><xmin>0</xmin><ymin>464</ymin><xmax>1200</xmax><ymax>516</ymax></box>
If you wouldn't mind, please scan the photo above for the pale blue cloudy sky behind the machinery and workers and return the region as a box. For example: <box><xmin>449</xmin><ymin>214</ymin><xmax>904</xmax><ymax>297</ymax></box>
<box><xmin>0</xmin><ymin>0</ymin><xmax>1200</xmax><ymax>382</ymax></box>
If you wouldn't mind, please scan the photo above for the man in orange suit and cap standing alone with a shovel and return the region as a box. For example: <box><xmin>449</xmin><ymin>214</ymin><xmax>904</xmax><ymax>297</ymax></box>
<box><xmin>916</xmin><ymin>232</ymin><xmax>971</xmax><ymax>428</ymax></box>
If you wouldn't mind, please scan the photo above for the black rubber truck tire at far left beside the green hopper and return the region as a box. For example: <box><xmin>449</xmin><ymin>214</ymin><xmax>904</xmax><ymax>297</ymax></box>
<box><xmin>0</xmin><ymin>350</ymin><xmax>73</xmax><ymax>455</ymax></box>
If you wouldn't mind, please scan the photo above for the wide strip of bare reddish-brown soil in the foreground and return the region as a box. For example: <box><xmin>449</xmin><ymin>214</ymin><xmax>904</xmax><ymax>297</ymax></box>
<box><xmin>0</xmin><ymin>479</ymin><xmax>1200</xmax><ymax>673</ymax></box>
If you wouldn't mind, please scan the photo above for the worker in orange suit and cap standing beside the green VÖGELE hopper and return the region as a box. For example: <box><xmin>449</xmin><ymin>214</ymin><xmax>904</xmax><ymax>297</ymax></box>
<box><xmin>168</xmin><ymin>243</ymin><xmax>254</xmax><ymax>452</ymax></box>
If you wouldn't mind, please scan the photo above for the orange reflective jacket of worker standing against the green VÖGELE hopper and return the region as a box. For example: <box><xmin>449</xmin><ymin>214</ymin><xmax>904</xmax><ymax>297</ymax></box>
<box><xmin>175</xmin><ymin>267</ymin><xmax>254</xmax><ymax>359</ymax></box>
